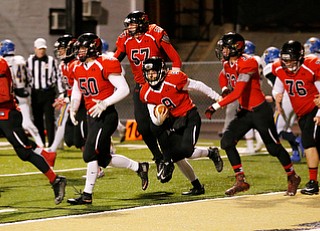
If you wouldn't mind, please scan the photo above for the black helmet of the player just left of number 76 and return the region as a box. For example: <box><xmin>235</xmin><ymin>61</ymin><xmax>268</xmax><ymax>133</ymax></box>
<box><xmin>215</xmin><ymin>32</ymin><xmax>245</xmax><ymax>60</ymax></box>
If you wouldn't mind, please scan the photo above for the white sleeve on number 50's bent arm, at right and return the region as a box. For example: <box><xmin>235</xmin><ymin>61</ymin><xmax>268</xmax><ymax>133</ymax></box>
<box><xmin>103</xmin><ymin>74</ymin><xmax>130</xmax><ymax>106</ymax></box>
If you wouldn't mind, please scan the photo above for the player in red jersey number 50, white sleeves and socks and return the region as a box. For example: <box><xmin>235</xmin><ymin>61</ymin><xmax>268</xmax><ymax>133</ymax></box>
<box><xmin>67</xmin><ymin>33</ymin><xmax>149</xmax><ymax>205</ymax></box>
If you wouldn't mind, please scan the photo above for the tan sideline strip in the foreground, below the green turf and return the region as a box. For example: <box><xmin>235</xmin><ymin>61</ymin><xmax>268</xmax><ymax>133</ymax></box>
<box><xmin>0</xmin><ymin>192</ymin><xmax>320</xmax><ymax>231</ymax></box>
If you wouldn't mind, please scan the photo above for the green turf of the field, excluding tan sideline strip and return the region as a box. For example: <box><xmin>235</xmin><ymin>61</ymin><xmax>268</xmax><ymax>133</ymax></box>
<box><xmin>0</xmin><ymin>139</ymin><xmax>308</xmax><ymax>223</ymax></box>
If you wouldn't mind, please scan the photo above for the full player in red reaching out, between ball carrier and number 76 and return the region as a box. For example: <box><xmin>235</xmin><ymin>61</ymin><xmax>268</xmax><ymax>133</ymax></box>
<box><xmin>206</xmin><ymin>32</ymin><xmax>301</xmax><ymax>196</ymax></box>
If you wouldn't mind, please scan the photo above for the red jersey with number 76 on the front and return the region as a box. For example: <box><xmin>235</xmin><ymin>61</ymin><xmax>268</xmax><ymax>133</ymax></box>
<box><xmin>272</xmin><ymin>57</ymin><xmax>320</xmax><ymax>117</ymax></box>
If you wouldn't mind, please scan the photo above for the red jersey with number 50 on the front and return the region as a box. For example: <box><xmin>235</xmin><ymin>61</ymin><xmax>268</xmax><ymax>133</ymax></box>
<box><xmin>71</xmin><ymin>56</ymin><xmax>122</xmax><ymax>110</ymax></box>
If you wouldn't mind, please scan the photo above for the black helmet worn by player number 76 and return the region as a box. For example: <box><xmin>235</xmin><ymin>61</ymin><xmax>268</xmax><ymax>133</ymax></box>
<box><xmin>280</xmin><ymin>40</ymin><xmax>304</xmax><ymax>74</ymax></box>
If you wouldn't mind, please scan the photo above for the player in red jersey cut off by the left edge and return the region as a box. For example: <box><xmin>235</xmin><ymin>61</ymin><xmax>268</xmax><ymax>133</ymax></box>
<box><xmin>0</xmin><ymin>57</ymin><xmax>67</xmax><ymax>204</ymax></box>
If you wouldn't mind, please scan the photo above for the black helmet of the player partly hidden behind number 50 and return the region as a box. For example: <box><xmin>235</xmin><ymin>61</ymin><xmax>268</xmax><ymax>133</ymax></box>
<box><xmin>54</xmin><ymin>34</ymin><xmax>77</xmax><ymax>62</ymax></box>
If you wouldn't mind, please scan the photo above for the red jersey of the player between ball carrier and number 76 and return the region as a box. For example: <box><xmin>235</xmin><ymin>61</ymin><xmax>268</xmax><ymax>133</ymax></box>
<box><xmin>219</xmin><ymin>54</ymin><xmax>265</xmax><ymax>110</ymax></box>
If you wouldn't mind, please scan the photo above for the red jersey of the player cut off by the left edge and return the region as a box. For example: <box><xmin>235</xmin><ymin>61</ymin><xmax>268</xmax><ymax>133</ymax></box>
<box><xmin>0</xmin><ymin>57</ymin><xmax>16</xmax><ymax>109</ymax></box>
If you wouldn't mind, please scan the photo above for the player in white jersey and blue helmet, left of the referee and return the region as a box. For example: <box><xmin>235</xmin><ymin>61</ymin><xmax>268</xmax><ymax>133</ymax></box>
<box><xmin>0</xmin><ymin>39</ymin><xmax>44</xmax><ymax>147</ymax></box>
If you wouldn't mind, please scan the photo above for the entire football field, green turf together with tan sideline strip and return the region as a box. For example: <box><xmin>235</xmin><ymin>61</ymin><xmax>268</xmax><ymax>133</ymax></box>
<box><xmin>0</xmin><ymin>138</ymin><xmax>320</xmax><ymax>231</ymax></box>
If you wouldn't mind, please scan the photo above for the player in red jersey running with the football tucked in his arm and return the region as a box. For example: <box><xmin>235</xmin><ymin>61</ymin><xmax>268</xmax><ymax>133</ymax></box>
<box><xmin>140</xmin><ymin>57</ymin><xmax>223</xmax><ymax>195</ymax></box>
